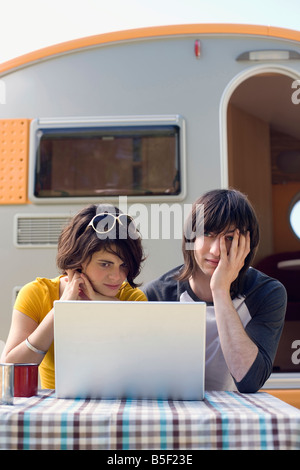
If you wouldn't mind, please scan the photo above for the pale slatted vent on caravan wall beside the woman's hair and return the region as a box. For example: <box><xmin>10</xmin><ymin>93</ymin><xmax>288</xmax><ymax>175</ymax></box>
<box><xmin>14</xmin><ymin>214</ymin><xmax>70</xmax><ymax>248</ymax></box>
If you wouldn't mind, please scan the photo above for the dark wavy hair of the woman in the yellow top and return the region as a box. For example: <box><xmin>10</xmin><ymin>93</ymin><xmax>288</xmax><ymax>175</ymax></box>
<box><xmin>56</xmin><ymin>204</ymin><xmax>144</xmax><ymax>287</ymax></box>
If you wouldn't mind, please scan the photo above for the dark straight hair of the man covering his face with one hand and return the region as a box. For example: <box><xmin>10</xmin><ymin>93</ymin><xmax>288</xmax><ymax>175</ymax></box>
<box><xmin>178</xmin><ymin>189</ymin><xmax>259</xmax><ymax>297</ymax></box>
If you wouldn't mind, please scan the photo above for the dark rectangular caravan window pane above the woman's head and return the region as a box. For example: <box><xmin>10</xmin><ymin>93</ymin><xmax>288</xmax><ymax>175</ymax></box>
<box><xmin>33</xmin><ymin>125</ymin><xmax>181</xmax><ymax>200</ymax></box>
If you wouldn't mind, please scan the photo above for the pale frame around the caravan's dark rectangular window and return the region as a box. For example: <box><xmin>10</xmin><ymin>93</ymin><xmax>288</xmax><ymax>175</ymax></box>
<box><xmin>28</xmin><ymin>115</ymin><xmax>186</xmax><ymax>204</ymax></box>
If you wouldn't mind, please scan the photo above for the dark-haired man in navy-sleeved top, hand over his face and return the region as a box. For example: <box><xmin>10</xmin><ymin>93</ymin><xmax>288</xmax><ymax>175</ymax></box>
<box><xmin>143</xmin><ymin>190</ymin><xmax>286</xmax><ymax>393</ymax></box>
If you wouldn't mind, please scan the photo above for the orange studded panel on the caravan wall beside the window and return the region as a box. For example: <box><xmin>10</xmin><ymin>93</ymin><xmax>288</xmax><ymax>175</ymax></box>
<box><xmin>0</xmin><ymin>119</ymin><xmax>30</xmax><ymax>204</ymax></box>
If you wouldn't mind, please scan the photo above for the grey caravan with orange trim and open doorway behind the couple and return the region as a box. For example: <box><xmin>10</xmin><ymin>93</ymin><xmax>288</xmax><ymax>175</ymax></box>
<box><xmin>0</xmin><ymin>24</ymin><xmax>300</xmax><ymax>402</ymax></box>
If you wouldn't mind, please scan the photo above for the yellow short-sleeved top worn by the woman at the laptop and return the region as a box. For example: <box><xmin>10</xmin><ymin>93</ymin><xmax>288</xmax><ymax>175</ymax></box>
<box><xmin>14</xmin><ymin>276</ymin><xmax>147</xmax><ymax>389</ymax></box>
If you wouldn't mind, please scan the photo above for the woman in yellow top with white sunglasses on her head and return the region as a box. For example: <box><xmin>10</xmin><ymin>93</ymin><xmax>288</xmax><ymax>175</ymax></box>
<box><xmin>1</xmin><ymin>205</ymin><xmax>147</xmax><ymax>389</ymax></box>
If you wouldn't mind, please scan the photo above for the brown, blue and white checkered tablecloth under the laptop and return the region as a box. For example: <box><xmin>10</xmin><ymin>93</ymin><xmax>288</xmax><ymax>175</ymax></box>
<box><xmin>0</xmin><ymin>390</ymin><xmax>300</xmax><ymax>450</ymax></box>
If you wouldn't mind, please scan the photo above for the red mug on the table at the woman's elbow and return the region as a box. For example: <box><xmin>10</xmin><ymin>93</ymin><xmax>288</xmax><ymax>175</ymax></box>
<box><xmin>14</xmin><ymin>363</ymin><xmax>39</xmax><ymax>397</ymax></box>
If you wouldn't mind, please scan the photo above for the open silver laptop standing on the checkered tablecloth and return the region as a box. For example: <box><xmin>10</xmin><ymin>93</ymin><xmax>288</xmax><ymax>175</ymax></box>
<box><xmin>54</xmin><ymin>301</ymin><xmax>206</xmax><ymax>400</ymax></box>
